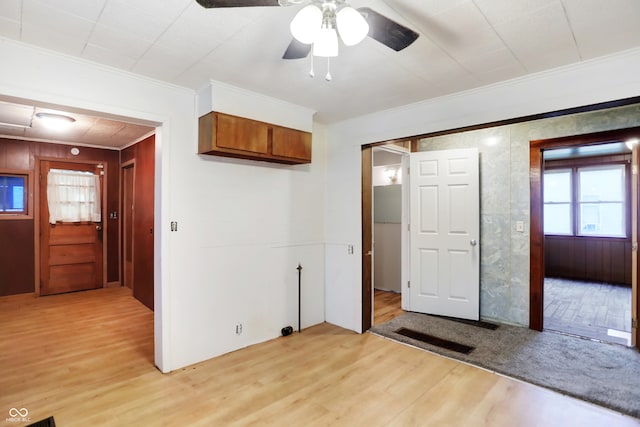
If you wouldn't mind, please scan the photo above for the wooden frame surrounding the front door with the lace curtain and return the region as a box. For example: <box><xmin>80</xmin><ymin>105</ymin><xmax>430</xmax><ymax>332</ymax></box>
<box><xmin>33</xmin><ymin>156</ymin><xmax>109</xmax><ymax>297</ymax></box>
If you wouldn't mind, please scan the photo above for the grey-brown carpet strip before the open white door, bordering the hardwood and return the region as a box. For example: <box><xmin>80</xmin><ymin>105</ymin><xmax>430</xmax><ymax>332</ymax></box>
<box><xmin>370</xmin><ymin>312</ymin><xmax>640</xmax><ymax>418</ymax></box>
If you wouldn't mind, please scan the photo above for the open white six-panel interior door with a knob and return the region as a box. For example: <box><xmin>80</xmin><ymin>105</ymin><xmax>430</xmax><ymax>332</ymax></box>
<box><xmin>409</xmin><ymin>148</ymin><xmax>480</xmax><ymax>320</ymax></box>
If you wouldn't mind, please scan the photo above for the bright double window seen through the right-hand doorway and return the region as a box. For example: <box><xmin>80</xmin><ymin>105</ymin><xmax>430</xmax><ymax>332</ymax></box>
<box><xmin>543</xmin><ymin>164</ymin><xmax>627</xmax><ymax>238</ymax></box>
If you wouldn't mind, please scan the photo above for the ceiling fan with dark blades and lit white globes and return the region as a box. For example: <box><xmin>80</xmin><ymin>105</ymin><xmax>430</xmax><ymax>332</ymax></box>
<box><xmin>196</xmin><ymin>0</ymin><xmax>418</xmax><ymax>80</ymax></box>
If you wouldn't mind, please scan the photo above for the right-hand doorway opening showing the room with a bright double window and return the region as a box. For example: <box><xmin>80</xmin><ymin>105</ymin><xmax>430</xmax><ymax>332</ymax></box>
<box><xmin>543</xmin><ymin>142</ymin><xmax>632</xmax><ymax>345</ymax></box>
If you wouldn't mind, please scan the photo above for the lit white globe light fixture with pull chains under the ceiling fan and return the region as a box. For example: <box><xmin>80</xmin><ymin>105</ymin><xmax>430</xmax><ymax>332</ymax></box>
<box><xmin>289</xmin><ymin>0</ymin><xmax>369</xmax><ymax>81</ymax></box>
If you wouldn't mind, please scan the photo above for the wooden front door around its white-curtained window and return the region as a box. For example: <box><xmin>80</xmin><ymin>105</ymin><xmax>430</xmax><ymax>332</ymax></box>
<box><xmin>39</xmin><ymin>160</ymin><xmax>104</xmax><ymax>295</ymax></box>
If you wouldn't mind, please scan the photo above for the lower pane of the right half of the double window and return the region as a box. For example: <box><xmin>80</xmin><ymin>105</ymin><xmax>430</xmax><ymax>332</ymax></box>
<box><xmin>580</xmin><ymin>203</ymin><xmax>626</xmax><ymax>237</ymax></box>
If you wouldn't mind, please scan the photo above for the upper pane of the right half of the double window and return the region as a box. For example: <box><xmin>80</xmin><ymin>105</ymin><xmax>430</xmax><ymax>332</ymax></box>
<box><xmin>580</xmin><ymin>165</ymin><xmax>625</xmax><ymax>202</ymax></box>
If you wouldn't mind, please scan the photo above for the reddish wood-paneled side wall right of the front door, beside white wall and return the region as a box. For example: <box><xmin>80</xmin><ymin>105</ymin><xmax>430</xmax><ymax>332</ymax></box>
<box><xmin>121</xmin><ymin>136</ymin><xmax>155</xmax><ymax>310</ymax></box>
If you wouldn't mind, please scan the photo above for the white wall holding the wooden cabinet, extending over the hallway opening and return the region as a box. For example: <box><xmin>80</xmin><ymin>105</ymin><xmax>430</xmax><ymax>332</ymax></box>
<box><xmin>0</xmin><ymin>39</ymin><xmax>325</xmax><ymax>372</ymax></box>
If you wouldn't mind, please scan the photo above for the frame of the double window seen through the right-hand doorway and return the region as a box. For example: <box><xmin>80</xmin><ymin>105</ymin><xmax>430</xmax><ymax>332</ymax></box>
<box><xmin>542</xmin><ymin>156</ymin><xmax>631</xmax><ymax>240</ymax></box>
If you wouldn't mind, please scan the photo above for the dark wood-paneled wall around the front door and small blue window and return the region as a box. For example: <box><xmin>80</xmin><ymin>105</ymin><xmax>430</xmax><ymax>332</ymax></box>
<box><xmin>0</xmin><ymin>138</ymin><xmax>120</xmax><ymax>296</ymax></box>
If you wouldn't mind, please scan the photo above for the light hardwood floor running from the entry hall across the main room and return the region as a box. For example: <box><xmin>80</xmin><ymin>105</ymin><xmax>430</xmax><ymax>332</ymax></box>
<box><xmin>0</xmin><ymin>288</ymin><xmax>638</xmax><ymax>427</ymax></box>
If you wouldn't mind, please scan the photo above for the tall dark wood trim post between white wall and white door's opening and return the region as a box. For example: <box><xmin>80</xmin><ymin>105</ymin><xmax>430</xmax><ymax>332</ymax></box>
<box><xmin>362</xmin><ymin>146</ymin><xmax>373</xmax><ymax>332</ymax></box>
